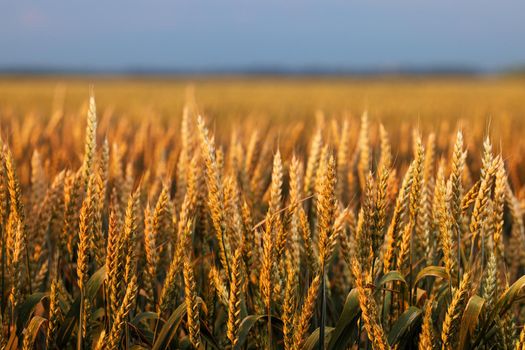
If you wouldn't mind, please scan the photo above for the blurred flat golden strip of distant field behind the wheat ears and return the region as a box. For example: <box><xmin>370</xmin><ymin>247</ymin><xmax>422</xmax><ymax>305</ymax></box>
<box><xmin>0</xmin><ymin>76</ymin><xmax>525</xmax><ymax>129</ymax></box>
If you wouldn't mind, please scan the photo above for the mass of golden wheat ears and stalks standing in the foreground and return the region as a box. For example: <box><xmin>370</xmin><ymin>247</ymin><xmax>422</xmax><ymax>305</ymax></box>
<box><xmin>0</xmin><ymin>91</ymin><xmax>525</xmax><ymax>349</ymax></box>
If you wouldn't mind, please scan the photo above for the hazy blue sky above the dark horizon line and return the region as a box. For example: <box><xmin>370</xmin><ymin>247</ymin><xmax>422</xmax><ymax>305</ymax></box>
<box><xmin>0</xmin><ymin>0</ymin><xmax>525</xmax><ymax>70</ymax></box>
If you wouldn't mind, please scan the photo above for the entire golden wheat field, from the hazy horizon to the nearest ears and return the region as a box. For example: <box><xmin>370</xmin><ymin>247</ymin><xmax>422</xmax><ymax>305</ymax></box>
<box><xmin>0</xmin><ymin>77</ymin><xmax>525</xmax><ymax>350</ymax></box>
